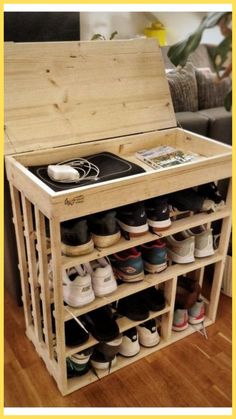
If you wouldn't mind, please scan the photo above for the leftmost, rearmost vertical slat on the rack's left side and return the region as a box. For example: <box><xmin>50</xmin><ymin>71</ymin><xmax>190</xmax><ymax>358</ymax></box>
<box><xmin>10</xmin><ymin>183</ymin><xmax>32</xmax><ymax>330</ymax></box>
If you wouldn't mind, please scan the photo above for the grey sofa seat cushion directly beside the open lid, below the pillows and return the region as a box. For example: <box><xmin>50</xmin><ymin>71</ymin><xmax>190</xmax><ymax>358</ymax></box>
<box><xmin>175</xmin><ymin>112</ymin><xmax>208</xmax><ymax>136</ymax></box>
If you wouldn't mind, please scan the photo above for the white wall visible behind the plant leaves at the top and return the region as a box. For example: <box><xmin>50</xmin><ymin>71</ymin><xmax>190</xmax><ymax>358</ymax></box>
<box><xmin>80</xmin><ymin>12</ymin><xmax>222</xmax><ymax>45</ymax></box>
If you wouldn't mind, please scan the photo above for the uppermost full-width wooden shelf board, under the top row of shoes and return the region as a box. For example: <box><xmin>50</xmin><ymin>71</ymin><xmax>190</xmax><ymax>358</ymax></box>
<box><xmin>62</xmin><ymin>206</ymin><xmax>230</xmax><ymax>269</ymax></box>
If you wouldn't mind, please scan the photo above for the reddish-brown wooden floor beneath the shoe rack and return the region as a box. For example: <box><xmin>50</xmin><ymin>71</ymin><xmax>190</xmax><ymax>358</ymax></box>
<box><xmin>5</xmin><ymin>294</ymin><xmax>232</xmax><ymax>407</ymax></box>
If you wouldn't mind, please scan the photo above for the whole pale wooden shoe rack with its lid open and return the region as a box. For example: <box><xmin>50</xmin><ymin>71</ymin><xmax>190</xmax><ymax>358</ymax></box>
<box><xmin>5</xmin><ymin>39</ymin><xmax>231</xmax><ymax>395</ymax></box>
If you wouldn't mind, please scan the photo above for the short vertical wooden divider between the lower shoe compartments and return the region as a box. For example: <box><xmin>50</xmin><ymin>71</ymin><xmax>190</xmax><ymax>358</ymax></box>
<box><xmin>161</xmin><ymin>277</ymin><xmax>177</xmax><ymax>340</ymax></box>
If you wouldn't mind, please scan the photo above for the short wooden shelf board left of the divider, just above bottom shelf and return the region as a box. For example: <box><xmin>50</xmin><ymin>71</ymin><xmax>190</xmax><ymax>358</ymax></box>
<box><xmin>66</xmin><ymin>305</ymin><xmax>170</xmax><ymax>357</ymax></box>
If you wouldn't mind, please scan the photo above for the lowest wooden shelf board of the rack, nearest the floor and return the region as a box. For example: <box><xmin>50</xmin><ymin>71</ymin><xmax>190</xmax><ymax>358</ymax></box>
<box><xmin>66</xmin><ymin>318</ymin><xmax>213</xmax><ymax>394</ymax></box>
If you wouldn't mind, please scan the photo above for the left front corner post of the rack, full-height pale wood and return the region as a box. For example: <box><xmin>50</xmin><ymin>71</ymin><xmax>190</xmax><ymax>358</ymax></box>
<box><xmin>49</xmin><ymin>218</ymin><xmax>67</xmax><ymax>394</ymax></box>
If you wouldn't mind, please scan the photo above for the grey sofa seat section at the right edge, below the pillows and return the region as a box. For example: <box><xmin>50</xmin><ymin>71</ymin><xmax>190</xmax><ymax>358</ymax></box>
<box><xmin>197</xmin><ymin>106</ymin><xmax>232</xmax><ymax>145</ymax></box>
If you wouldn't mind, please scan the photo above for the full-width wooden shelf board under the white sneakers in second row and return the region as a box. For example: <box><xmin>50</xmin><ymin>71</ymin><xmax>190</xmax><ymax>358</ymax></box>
<box><xmin>64</xmin><ymin>252</ymin><xmax>222</xmax><ymax>321</ymax></box>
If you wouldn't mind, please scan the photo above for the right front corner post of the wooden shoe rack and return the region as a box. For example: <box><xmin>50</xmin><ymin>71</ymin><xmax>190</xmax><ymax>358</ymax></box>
<box><xmin>207</xmin><ymin>179</ymin><xmax>232</xmax><ymax>321</ymax></box>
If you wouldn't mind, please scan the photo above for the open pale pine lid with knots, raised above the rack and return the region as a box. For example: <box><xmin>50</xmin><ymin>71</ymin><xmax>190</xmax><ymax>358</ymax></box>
<box><xmin>5</xmin><ymin>39</ymin><xmax>176</xmax><ymax>154</ymax></box>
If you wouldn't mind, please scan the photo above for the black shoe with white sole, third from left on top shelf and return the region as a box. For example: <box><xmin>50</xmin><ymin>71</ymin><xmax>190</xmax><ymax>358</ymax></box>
<box><xmin>116</xmin><ymin>202</ymin><xmax>148</xmax><ymax>236</ymax></box>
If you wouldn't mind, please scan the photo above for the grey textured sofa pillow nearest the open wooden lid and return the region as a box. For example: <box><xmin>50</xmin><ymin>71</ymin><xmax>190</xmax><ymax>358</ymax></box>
<box><xmin>166</xmin><ymin>63</ymin><xmax>198</xmax><ymax>112</ymax></box>
